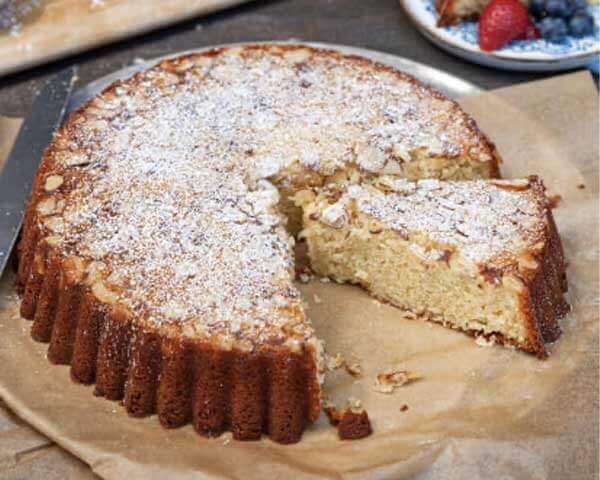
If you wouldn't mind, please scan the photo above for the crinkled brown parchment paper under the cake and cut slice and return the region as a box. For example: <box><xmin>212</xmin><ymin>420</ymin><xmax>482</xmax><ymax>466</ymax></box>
<box><xmin>0</xmin><ymin>72</ymin><xmax>600</xmax><ymax>480</ymax></box>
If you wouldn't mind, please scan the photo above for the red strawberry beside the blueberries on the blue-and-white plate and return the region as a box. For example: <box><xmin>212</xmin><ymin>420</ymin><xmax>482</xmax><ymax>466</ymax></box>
<box><xmin>479</xmin><ymin>0</ymin><xmax>539</xmax><ymax>52</ymax></box>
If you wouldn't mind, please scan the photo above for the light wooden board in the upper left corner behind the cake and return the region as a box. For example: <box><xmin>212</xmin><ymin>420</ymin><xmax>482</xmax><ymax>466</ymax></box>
<box><xmin>0</xmin><ymin>0</ymin><xmax>247</xmax><ymax>76</ymax></box>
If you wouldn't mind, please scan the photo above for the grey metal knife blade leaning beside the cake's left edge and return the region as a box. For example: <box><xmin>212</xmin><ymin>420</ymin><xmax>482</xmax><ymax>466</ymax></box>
<box><xmin>0</xmin><ymin>67</ymin><xmax>76</xmax><ymax>276</ymax></box>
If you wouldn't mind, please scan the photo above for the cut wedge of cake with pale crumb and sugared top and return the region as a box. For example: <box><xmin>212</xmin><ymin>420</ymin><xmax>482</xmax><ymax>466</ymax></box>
<box><xmin>297</xmin><ymin>176</ymin><xmax>568</xmax><ymax>357</ymax></box>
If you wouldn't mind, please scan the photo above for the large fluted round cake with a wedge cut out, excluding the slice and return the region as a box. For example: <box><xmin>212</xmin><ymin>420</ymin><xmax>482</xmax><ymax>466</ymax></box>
<box><xmin>17</xmin><ymin>45</ymin><xmax>506</xmax><ymax>443</ymax></box>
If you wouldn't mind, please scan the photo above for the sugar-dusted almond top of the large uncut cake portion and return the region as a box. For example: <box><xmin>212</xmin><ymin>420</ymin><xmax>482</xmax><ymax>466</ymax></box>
<box><xmin>39</xmin><ymin>47</ymin><xmax>490</xmax><ymax>339</ymax></box>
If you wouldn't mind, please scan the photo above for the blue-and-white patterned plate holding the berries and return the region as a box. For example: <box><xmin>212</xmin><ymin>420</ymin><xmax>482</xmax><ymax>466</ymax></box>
<box><xmin>400</xmin><ymin>0</ymin><xmax>600</xmax><ymax>72</ymax></box>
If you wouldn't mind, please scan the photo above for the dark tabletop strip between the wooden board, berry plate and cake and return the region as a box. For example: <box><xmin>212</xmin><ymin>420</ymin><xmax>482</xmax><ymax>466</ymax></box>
<box><xmin>0</xmin><ymin>0</ymin><xmax>596</xmax><ymax>116</ymax></box>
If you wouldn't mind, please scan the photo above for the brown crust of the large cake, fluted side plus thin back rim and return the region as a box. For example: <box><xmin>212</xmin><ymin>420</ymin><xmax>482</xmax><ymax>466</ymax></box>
<box><xmin>16</xmin><ymin>45</ymin><xmax>506</xmax><ymax>443</ymax></box>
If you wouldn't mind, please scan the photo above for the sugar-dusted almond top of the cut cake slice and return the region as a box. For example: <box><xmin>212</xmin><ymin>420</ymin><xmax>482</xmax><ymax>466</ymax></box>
<box><xmin>339</xmin><ymin>178</ymin><xmax>546</xmax><ymax>265</ymax></box>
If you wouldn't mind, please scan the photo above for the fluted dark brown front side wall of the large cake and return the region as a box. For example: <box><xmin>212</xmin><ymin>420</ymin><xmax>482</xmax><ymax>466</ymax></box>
<box><xmin>16</xmin><ymin>238</ymin><xmax>319</xmax><ymax>443</ymax></box>
